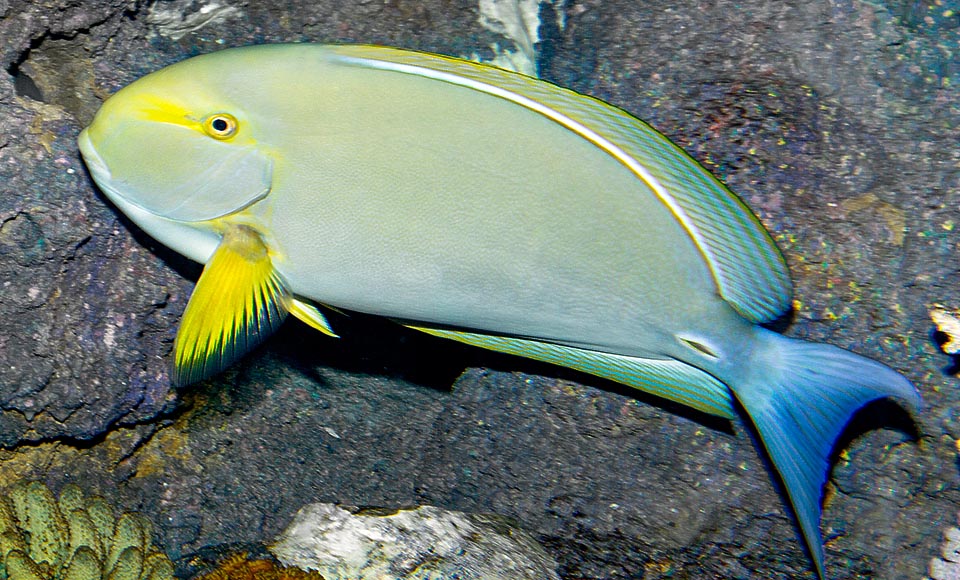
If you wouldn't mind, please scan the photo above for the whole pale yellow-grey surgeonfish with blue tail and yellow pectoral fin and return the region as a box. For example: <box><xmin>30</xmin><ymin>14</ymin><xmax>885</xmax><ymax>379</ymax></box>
<box><xmin>79</xmin><ymin>44</ymin><xmax>920</xmax><ymax>577</ymax></box>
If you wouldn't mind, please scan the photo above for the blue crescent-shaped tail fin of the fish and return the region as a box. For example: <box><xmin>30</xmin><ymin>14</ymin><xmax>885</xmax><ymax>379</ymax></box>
<box><xmin>731</xmin><ymin>328</ymin><xmax>920</xmax><ymax>578</ymax></box>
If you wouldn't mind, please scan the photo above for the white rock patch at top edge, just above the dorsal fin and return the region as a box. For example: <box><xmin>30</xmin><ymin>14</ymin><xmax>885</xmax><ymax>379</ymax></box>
<box><xmin>474</xmin><ymin>0</ymin><xmax>565</xmax><ymax>76</ymax></box>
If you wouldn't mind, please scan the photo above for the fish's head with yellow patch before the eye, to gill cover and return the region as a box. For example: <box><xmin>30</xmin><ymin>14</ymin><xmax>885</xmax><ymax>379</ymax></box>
<box><xmin>78</xmin><ymin>51</ymin><xmax>273</xmax><ymax>261</ymax></box>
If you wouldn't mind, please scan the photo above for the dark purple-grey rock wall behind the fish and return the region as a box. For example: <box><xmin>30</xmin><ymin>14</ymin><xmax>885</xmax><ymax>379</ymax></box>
<box><xmin>0</xmin><ymin>0</ymin><xmax>960</xmax><ymax>579</ymax></box>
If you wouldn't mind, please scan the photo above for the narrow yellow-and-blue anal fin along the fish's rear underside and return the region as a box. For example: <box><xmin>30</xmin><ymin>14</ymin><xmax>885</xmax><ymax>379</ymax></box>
<box><xmin>401</xmin><ymin>323</ymin><xmax>736</xmax><ymax>419</ymax></box>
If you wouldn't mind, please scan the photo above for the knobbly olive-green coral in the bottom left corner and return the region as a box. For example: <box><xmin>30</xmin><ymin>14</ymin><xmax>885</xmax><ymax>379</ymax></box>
<box><xmin>0</xmin><ymin>481</ymin><xmax>173</xmax><ymax>580</ymax></box>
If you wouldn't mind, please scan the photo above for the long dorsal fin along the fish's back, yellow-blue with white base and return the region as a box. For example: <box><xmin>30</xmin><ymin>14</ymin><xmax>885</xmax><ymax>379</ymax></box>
<box><xmin>332</xmin><ymin>45</ymin><xmax>792</xmax><ymax>322</ymax></box>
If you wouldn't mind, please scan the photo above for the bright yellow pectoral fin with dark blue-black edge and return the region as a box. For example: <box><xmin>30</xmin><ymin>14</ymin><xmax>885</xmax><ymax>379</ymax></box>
<box><xmin>173</xmin><ymin>226</ymin><xmax>290</xmax><ymax>386</ymax></box>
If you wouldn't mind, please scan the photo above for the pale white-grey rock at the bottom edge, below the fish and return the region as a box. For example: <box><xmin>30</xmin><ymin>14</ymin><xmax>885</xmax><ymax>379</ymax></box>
<box><xmin>270</xmin><ymin>503</ymin><xmax>559</xmax><ymax>580</ymax></box>
